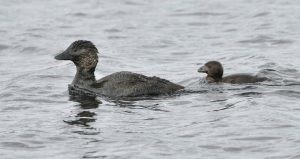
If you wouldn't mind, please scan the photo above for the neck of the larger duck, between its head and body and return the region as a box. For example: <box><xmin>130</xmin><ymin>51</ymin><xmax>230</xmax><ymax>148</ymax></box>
<box><xmin>72</xmin><ymin>66</ymin><xmax>96</xmax><ymax>86</ymax></box>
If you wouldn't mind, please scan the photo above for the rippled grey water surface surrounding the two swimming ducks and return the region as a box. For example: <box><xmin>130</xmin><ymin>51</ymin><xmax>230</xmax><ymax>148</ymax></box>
<box><xmin>0</xmin><ymin>0</ymin><xmax>300</xmax><ymax>159</ymax></box>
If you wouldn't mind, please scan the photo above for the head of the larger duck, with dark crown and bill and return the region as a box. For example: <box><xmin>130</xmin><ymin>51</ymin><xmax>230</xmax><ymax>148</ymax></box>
<box><xmin>55</xmin><ymin>40</ymin><xmax>98</xmax><ymax>70</ymax></box>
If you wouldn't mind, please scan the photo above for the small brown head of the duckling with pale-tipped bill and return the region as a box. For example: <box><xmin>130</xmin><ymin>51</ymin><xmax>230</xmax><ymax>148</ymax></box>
<box><xmin>198</xmin><ymin>61</ymin><xmax>223</xmax><ymax>82</ymax></box>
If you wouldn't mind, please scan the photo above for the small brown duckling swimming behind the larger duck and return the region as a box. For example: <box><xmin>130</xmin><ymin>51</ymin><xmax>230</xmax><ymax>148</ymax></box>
<box><xmin>198</xmin><ymin>61</ymin><xmax>269</xmax><ymax>84</ymax></box>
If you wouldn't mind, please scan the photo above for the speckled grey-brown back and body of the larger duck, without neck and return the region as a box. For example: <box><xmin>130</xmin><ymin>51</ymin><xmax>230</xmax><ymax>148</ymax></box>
<box><xmin>91</xmin><ymin>71</ymin><xmax>183</xmax><ymax>97</ymax></box>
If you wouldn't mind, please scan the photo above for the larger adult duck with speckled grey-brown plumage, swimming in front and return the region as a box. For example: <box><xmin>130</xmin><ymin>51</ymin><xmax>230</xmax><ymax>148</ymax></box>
<box><xmin>55</xmin><ymin>40</ymin><xmax>184</xmax><ymax>98</ymax></box>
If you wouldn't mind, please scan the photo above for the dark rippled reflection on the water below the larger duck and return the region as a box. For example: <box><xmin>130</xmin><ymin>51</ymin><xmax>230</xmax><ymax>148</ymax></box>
<box><xmin>64</xmin><ymin>96</ymin><xmax>102</xmax><ymax>127</ymax></box>
